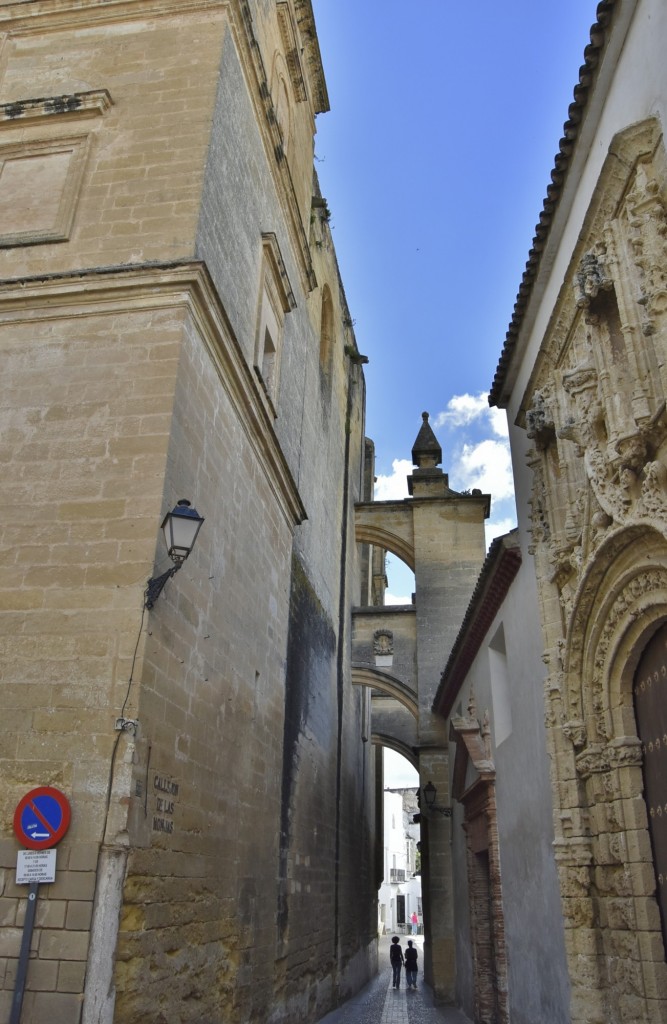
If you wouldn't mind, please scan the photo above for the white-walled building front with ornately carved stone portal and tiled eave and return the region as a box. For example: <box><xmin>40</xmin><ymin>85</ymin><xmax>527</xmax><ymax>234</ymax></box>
<box><xmin>491</xmin><ymin>0</ymin><xmax>667</xmax><ymax>1024</ymax></box>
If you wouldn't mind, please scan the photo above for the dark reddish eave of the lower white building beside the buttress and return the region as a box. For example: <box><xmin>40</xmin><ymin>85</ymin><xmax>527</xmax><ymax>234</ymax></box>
<box><xmin>432</xmin><ymin>532</ymin><xmax>522</xmax><ymax>718</ymax></box>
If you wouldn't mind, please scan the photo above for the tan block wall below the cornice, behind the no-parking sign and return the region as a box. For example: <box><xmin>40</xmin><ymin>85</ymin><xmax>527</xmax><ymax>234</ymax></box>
<box><xmin>0</xmin><ymin>274</ymin><xmax>181</xmax><ymax>1022</ymax></box>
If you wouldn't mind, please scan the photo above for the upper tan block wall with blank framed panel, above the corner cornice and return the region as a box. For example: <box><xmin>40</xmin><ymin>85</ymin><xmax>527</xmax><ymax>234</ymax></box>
<box><xmin>0</xmin><ymin>3</ymin><xmax>226</xmax><ymax>279</ymax></box>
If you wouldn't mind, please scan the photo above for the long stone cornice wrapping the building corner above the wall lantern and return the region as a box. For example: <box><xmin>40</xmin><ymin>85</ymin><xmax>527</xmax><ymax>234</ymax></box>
<box><xmin>0</xmin><ymin>261</ymin><xmax>307</xmax><ymax>529</ymax></box>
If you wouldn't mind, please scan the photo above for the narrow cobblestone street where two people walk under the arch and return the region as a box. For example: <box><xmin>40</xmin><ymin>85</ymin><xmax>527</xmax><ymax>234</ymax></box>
<box><xmin>319</xmin><ymin>935</ymin><xmax>470</xmax><ymax>1024</ymax></box>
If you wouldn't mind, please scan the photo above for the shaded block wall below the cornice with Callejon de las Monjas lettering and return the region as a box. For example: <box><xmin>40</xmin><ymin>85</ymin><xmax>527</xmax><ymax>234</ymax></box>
<box><xmin>116</xmin><ymin>292</ymin><xmax>301</xmax><ymax>1021</ymax></box>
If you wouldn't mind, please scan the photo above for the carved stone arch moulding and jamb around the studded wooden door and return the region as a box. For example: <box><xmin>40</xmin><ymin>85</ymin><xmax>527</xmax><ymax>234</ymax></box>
<box><xmin>550</xmin><ymin>524</ymin><xmax>667</xmax><ymax>1021</ymax></box>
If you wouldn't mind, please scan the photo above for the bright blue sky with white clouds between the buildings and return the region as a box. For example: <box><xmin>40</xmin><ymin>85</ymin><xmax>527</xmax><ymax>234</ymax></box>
<box><xmin>314</xmin><ymin>0</ymin><xmax>596</xmax><ymax>784</ymax></box>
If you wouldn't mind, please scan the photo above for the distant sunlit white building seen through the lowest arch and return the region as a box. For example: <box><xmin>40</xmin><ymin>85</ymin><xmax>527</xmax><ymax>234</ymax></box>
<box><xmin>378</xmin><ymin>788</ymin><xmax>422</xmax><ymax>935</ymax></box>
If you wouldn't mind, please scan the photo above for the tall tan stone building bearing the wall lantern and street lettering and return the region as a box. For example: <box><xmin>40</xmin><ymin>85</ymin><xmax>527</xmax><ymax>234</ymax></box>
<box><xmin>0</xmin><ymin>0</ymin><xmax>379</xmax><ymax>1024</ymax></box>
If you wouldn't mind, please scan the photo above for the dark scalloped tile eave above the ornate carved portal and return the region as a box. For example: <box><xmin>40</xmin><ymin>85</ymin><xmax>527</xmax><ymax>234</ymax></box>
<box><xmin>489</xmin><ymin>0</ymin><xmax>636</xmax><ymax>407</ymax></box>
